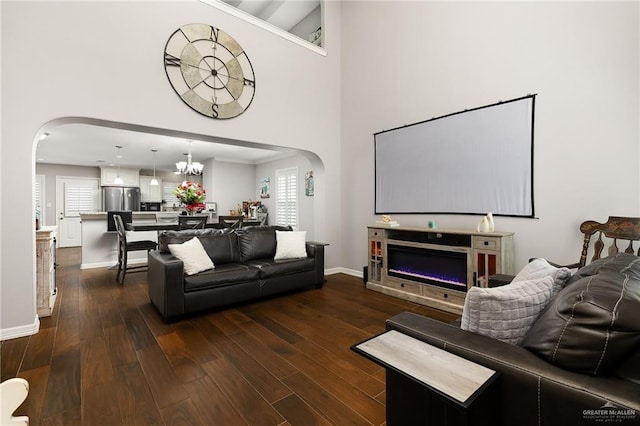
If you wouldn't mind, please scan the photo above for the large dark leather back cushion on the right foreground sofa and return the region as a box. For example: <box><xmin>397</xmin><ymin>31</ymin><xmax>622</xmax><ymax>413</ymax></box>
<box><xmin>522</xmin><ymin>253</ymin><xmax>640</xmax><ymax>375</ymax></box>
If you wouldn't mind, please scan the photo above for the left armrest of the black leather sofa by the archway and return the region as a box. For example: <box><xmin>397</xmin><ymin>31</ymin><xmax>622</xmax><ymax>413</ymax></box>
<box><xmin>147</xmin><ymin>250</ymin><xmax>184</xmax><ymax>322</ymax></box>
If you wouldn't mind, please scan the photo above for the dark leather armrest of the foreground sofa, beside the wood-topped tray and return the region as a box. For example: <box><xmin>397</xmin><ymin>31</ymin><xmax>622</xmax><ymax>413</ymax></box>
<box><xmin>386</xmin><ymin>312</ymin><xmax>640</xmax><ymax>426</ymax></box>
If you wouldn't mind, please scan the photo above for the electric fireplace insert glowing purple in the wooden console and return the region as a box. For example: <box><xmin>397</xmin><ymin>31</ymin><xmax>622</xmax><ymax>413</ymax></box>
<box><xmin>387</xmin><ymin>244</ymin><xmax>467</xmax><ymax>292</ymax></box>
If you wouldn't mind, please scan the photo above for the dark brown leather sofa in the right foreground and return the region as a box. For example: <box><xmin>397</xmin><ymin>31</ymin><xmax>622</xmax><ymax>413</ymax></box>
<box><xmin>386</xmin><ymin>254</ymin><xmax>640</xmax><ymax>426</ymax></box>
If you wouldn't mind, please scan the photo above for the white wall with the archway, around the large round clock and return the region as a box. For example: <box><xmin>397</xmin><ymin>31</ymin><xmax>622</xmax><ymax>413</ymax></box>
<box><xmin>0</xmin><ymin>0</ymin><xmax>340</xmax><ymax>338</ymax></box>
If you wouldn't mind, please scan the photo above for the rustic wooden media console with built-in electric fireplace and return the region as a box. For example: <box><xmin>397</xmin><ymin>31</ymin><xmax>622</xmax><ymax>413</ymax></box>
<box><xmin>366</xmin><ymin>226</ymin><xmax>513</xmax><ymax>314</ymax></box>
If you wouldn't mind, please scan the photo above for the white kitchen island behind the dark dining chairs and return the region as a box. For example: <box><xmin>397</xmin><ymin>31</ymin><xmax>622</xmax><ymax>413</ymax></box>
<box><xmin>80</xmin><ymin>212</ymin><xmax>180</xmax><ymax>269</ymax></box>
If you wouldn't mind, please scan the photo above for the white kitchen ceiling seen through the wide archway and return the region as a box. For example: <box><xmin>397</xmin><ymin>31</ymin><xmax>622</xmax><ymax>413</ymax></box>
<box><xmin>36</xmin><ymin>123</ymin><xmax>292</xmax><ymax>171</ymax></box>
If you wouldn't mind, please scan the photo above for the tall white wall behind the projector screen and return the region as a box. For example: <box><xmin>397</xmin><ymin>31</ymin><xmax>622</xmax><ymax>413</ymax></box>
<box><xmin>341</xmin><ymin>1</ymin><xmax>640</xmax><ymax>270</ymax></box>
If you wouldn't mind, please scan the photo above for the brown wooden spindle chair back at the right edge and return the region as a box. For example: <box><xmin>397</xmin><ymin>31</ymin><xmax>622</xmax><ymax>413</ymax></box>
<box><xmin>576</xmin><ymin>216</ymin><xmax>640</xmax><ymax>268</ymax></box>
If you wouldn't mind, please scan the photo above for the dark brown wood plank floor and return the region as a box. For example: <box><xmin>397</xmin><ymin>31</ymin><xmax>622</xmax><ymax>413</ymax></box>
<box><xmin>0</xmin><ymin>248</ymin><xmax>453</xmax><ymax>426</ymax></box>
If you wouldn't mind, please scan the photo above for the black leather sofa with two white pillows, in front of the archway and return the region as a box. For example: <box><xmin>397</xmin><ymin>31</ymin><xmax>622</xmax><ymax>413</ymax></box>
<box><xmin>148</xmin><ymin>226</ymin><xmax>324</xmax><ymax>322</ymax></box>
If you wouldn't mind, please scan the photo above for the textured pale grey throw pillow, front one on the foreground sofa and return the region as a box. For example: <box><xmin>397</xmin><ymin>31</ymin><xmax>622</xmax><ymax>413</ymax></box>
<box><xmin>460</xmin><ymin>276</ymin><xmax>553</xmax><ymax>345</ymax></box>
